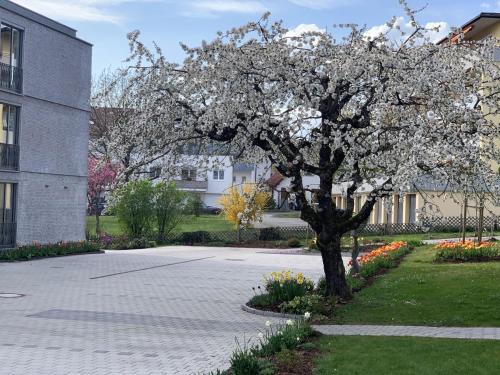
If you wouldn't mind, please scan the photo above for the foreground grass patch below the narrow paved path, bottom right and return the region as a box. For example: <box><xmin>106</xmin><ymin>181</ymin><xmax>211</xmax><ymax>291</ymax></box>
<box><xmin>314</xmin><ymin>336</ymin><xmax>500</xmax><ymax>375</ymax></box>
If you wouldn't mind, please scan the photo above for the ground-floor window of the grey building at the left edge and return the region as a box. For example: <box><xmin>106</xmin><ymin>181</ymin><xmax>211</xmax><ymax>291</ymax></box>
<box><xmin>0</xmin><ymin>183</ymin><xmax>16</xmax><ymax>247</ymax></box>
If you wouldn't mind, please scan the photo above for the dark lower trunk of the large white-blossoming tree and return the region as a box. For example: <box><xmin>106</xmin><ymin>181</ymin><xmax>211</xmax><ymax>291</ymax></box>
<box><xmin>318</xmin><ymin>234</ymin><xmax>352</xmax><ymax>300</ymax></box>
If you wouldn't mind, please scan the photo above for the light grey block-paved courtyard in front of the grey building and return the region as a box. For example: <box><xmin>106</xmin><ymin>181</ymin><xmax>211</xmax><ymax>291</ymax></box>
<box><xmin>0</xmin><ymin>247</ymin><xmax>332</xmax><ymax>375</ymax></box>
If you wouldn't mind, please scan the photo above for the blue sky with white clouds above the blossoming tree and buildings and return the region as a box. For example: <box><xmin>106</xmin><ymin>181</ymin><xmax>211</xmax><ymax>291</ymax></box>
<box><xmin>8</xmin><ymin>0</ymin><xmax>500</xmax><ymax>76</ymax></box>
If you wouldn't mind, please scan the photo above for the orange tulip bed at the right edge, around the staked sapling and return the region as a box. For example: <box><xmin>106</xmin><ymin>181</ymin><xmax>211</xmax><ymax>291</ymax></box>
<box><xmin>434</xmin><ymin>240</ymin><xmax>500</xmax><ymax>262</ymax></box>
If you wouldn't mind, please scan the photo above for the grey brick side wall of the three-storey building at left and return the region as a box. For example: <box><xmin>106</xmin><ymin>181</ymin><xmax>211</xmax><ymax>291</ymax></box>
<box><xmin>0</xmin><ymin>1</ymin><xmax>92</xmax><ymax>244</ymax></box>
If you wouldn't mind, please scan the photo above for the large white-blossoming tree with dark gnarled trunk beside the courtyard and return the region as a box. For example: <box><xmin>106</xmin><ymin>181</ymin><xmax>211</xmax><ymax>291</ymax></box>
<box><xmin>123</xmin><ymin>0</ymin><xmax>500</xmax><ymax>298</ymax></box>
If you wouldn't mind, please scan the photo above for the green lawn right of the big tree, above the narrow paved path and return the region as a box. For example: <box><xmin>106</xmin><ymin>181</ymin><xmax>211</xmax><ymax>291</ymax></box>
<box><xmin>335</xmin><ymin>246</ymin><xmax>500</xmax><ymax>327</ymax></box>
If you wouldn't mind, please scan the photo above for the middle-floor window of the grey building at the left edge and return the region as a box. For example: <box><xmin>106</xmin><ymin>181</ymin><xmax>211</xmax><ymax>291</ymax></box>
<box><xmin>0</xmin><ymin>103</ymin><xmax>19</xmax><ymax>170</ymax></box>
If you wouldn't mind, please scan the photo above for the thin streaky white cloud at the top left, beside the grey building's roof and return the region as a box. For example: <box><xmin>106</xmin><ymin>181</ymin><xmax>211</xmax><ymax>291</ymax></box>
<box><xmin>12</xmin><ymin>0</ymin><xmax>158</xmax><ymax>24</ymax></box>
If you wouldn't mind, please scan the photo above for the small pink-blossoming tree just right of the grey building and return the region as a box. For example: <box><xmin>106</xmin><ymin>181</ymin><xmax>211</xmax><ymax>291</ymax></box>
<box><xmin>87</xmin><ymin>157</ymin><xmax>118</xmax><ymax>235</ymax></box>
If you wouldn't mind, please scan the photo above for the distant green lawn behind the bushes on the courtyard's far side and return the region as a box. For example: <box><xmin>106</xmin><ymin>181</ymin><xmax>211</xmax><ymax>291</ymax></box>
<box><xmin>87</xmin><ymin>215</ymin><xmax>234</xmax><ymax>235</ymax></box>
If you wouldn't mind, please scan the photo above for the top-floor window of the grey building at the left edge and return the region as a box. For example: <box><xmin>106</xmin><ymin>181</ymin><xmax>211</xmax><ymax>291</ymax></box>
<box><xmin>0</xmin><ymin>24</ymin><xmax>22</xmax><ymax>92</ymax></box>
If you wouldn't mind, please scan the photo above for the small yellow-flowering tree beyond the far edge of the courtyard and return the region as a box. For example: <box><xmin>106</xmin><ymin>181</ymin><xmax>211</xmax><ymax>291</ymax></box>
<box><xmin>219</xmin><ymin>184</ymin><xmax>271</xmax><ymax>241</ymax></box>
